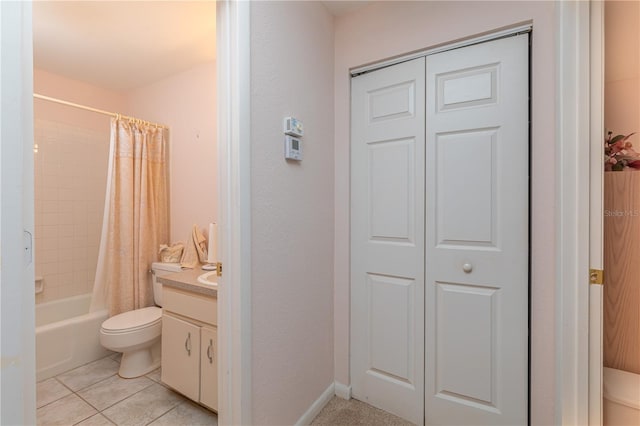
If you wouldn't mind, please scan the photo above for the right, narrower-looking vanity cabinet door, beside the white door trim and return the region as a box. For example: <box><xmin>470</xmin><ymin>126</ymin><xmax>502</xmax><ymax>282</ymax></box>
<box><xmin>200</xmin><ymin>327</ymin><xmax>218</xmax><ymax>411</ymax></box>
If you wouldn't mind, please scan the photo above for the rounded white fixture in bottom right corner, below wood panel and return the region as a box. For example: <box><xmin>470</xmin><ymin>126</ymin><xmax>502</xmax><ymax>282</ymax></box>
<box><xmin>603</xmin><ymin>367</ymin><xmax>640</xmax><ymax>426</ymax></box>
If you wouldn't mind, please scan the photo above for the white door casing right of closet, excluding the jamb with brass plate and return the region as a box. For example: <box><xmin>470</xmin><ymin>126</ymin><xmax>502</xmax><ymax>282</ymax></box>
<box><xmin>556</xmin><ymin>1</ymin><xmax>590</xmax><ymax>425</ymax></box>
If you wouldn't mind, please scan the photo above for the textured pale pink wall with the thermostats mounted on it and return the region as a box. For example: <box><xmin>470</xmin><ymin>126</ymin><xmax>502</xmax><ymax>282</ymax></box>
<box><xmin>251</xmin><ymin>2</ymin><xmax>334</xmax><ymax>425</ymax></box>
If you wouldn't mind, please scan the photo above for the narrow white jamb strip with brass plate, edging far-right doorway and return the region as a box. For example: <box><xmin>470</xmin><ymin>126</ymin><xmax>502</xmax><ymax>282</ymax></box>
<box><xmin>589</xmin><ymin>1</ymin><xmax>604</xmax><ymax>426</ymax></box>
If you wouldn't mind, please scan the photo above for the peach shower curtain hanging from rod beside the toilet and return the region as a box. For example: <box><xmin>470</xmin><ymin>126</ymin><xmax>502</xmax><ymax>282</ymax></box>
<box><xmin>91</xmin><ymin>118</ymin><xmax>169</xmax><ymax>316</ymax></box>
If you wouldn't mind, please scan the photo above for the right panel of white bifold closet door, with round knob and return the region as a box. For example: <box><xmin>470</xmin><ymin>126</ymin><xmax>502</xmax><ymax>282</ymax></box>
<box><xmin>425</xmin><ymin>35</ymin><xmax>529</xmax><ymax>425</ymax></box>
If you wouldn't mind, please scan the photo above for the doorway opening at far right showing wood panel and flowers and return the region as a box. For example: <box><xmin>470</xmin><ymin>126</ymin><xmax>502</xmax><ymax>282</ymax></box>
<box><xmin>592</xmin><ymin>2</ymin><xmax>640</xmax><ymax>426</ymax></box>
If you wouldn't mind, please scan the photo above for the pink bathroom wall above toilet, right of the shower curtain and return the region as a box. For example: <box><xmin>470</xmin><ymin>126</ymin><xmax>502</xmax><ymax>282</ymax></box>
<box><xmin>127</xmin><ymin>62</ymin><xmax>218</xmax><ymax>242</ymax></box>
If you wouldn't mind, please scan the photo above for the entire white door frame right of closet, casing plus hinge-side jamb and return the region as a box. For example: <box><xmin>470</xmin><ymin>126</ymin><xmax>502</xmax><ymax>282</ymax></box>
<box><xmin>556</xmin><ymin>0</ymin><xmax>604</xmax><ymax>425</ymax></box>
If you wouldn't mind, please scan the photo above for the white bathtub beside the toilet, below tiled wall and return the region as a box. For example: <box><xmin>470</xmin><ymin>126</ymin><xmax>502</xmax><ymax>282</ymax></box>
<box><xmin>36</xmin><ymin>294</ymin><xmax>112</xmax><ymax>381</ymax></box>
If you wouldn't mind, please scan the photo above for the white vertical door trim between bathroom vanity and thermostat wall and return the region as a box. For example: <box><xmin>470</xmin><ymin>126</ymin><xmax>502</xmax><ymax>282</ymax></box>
<box><xmin>216</xmin><ymin>0</ymin><xmax>252</xmax><ymax>425</ymax></box>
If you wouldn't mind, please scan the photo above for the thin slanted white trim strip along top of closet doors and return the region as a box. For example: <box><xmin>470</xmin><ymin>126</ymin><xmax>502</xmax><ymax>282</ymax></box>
<box><xmin>351</xmin><ymin>24</ymin><xmax>533</xmax><ymax>77</ymax></box>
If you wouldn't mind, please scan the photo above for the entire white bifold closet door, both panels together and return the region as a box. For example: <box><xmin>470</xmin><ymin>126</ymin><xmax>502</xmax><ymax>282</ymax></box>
<box><xmin>351</xmin><ymin>35</ymin><xmax>529</xmax><ymax>425</ymax></box>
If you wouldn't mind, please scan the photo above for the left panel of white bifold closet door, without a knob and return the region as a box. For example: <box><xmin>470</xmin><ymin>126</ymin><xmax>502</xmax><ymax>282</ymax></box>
<box><xmin>351</xmin><ymin>58</ymin><xmax>425</xmax><ymax>424</ymax></box>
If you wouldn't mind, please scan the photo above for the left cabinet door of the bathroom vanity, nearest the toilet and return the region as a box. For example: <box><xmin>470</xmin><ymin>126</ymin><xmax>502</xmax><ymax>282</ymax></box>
<box><xmin>162</xmin><ymin>314</ymin><xmax>200</xmax><ymax>401</ymax></box>
